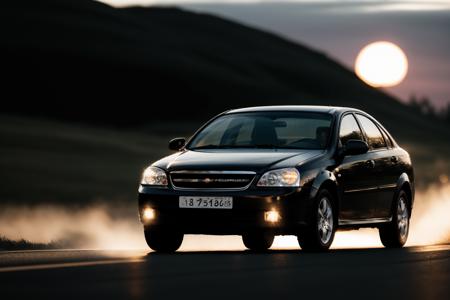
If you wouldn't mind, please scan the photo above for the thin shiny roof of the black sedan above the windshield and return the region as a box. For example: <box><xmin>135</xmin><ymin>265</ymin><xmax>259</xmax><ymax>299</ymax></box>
<box><xmin>225</xmin><ymin>105</ymin><xmax>361</xmax><ymax>114</ymax></box>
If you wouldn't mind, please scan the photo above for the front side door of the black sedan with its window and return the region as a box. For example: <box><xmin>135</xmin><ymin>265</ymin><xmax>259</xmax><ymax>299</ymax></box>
<box><xmin>336</xmin><ymin>114</ymin><xmax>376</xmax><ymax>220</ymax></box>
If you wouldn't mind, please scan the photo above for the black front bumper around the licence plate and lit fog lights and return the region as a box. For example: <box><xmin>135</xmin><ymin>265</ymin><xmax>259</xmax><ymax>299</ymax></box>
<box><xmin>139</xmin><ymin>186</ymin><xmax>309</xmax><ymax>235</ymax></box>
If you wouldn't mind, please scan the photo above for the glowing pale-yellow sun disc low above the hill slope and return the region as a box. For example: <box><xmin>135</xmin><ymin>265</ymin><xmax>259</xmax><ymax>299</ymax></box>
<box><xmin>355</xmin><ymin>41</ymin><xmax>408</xmax><ymax>87</ymax></box>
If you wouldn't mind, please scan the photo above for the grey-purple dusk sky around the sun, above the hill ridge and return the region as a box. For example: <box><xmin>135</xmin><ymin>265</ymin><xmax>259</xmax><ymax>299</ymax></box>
<box><xmin>104</xmin><ymin>0</ymin><xmax>450</xmax><ymax>107</ymax></box>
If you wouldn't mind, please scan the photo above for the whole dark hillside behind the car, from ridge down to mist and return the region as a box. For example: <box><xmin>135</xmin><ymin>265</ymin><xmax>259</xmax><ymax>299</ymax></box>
<box><xmin>0</xmin><ymin>0</ymin><xmax>450</xmax><ymax>203</ymax></box>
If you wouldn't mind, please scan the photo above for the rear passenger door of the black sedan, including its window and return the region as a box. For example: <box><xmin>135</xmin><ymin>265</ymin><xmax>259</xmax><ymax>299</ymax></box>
<box><xmin>356</xmin><ymin>114</ymin><xmax>396</xmax><ymax>218</ymax></box>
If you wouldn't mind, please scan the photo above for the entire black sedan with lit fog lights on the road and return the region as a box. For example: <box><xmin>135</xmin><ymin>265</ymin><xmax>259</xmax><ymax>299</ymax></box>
<box><xmin>139</xmin><ymin>106</ymin><xmax>414</xmax><ymax>252</ymax></box>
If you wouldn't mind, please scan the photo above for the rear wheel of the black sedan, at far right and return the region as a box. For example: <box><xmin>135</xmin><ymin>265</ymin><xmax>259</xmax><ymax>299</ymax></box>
<box><xmin>378</xmin><ymin>190</ymin><xmax>410</xmax><ymax>248</ymax></box>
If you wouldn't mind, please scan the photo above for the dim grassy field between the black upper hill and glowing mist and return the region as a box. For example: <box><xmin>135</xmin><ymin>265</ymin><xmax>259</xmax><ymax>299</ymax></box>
<box><xmin>0</xmin><ymin>116</ymin><xmax>450</xmax><ymax>206</ymax></box>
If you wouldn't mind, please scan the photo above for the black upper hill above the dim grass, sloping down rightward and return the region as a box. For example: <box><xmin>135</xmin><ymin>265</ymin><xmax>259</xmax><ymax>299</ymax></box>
<box><xmin>0</xmin><ymin>0</ymin><xmax>444</xmax><ymax>139</ymax></box>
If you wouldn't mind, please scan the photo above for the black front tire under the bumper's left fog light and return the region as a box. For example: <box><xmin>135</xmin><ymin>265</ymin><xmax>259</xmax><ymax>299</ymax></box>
<box><xmin>144</xmin><ymin>229</ymin><xmax>184</xmax><ymax>253</ymax></box>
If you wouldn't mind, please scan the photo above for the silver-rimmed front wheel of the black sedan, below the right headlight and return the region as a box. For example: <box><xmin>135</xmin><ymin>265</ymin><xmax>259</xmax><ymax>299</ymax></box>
<box><xmin>297</xmin><ymin>189</ymin><xmax>337</xmax><ymax>252</ymax></box>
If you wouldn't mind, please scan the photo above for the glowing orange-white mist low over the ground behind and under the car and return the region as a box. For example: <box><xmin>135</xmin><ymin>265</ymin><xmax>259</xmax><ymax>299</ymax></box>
<box><xmin>0</xmin><ymin>183</ymin><xmax>450</xmax><ymax>251</ymax></box>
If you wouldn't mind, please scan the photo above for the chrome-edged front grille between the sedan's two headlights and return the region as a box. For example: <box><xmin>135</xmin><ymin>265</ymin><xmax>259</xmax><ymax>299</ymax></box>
<box><xmin>170</xmin><ymin>171</ymin><xmax>255</xmax><ymax>190</ymax></box>
